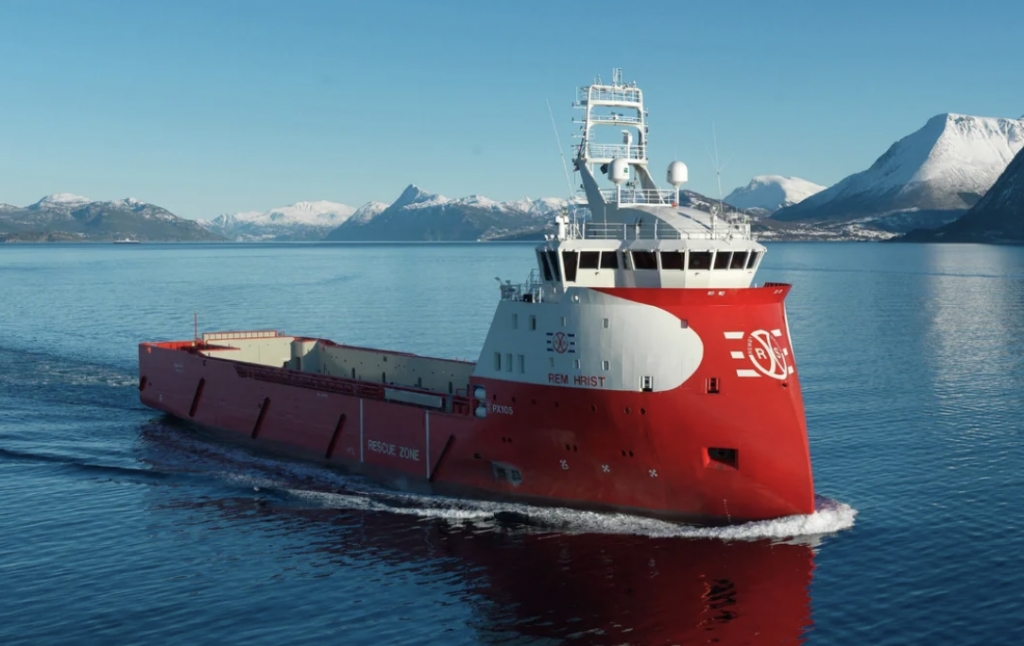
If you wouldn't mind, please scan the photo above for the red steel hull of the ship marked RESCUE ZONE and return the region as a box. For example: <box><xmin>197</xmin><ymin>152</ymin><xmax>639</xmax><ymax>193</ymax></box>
<box><xmin>139</xmin><ymin>286</ymin><xmax>814</xmax><ymax>522</ymax></box>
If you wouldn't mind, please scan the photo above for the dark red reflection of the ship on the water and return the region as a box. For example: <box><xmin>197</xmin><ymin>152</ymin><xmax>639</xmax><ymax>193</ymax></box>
<box><xmin>151</xmin><ymin>489</ymin><xmax>814</xmax><ymax>644</ymax></box>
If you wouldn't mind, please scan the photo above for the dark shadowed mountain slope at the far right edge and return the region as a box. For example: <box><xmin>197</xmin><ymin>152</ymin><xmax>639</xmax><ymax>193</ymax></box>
<box><xmin>907</xmin><ymin>149</ymin><xmax>1024</xmax><ymax>243</ymax></box>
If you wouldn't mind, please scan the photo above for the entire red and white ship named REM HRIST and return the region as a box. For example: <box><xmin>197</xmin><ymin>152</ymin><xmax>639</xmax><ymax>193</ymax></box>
<box><xmin>139</xmin><ymin>70</ymin><xmax>814</xmax><ymax>523</ymax></box>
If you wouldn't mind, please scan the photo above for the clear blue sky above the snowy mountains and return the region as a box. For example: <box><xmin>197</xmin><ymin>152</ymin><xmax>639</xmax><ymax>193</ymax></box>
<box><xmin>0</xmin><ymin>0</ymin><xmax>1024</xmax><ymax>218</ymax></box>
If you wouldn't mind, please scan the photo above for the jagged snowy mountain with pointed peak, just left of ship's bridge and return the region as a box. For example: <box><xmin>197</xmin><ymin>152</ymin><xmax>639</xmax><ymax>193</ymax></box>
<box><xmin>327</xmin><ymin>184</ymin><xmax>568</xmax><ymax>241</ymax></box>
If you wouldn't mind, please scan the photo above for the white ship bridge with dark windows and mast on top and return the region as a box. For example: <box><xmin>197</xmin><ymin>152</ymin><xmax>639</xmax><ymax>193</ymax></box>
<box><xmin>491</xmin><ymin>69</ymin><xmax>765</xmax><ymax>294</ymax></box>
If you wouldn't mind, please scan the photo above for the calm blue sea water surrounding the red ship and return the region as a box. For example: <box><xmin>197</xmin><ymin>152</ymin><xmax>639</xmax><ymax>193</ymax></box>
<box><xmin>0</xmin><ymin>244</ymin><xmax>1024</xmax><ymax>646</ymax></box>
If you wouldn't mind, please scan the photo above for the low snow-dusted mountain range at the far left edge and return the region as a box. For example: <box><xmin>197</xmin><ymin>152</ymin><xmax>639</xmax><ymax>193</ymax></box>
<box><xmin>0</xmin><ymin>192</ymin><xmax>221</xmax><ymax>242</ymax></box>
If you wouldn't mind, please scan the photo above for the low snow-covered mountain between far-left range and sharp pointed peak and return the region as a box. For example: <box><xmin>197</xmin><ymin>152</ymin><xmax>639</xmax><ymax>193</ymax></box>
<box><xmin>202</xmin><ymin>200</ymin><xmax>355</xmax><ymax>241</ymax></box>
